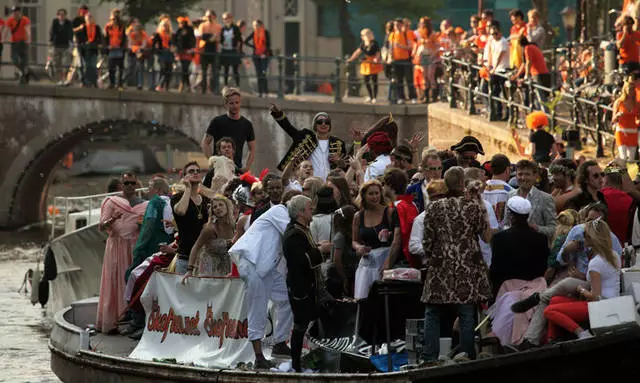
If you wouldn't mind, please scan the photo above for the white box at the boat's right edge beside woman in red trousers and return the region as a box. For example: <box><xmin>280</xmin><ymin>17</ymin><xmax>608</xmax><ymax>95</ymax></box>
<box><xmin>589</xmin><ymin>295</ymin><xmax>640</xmax><ymax>334</ymax></box>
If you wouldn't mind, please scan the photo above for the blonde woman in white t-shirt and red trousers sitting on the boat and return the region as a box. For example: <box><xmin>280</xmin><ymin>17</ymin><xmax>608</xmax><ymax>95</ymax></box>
<box><xmin>544</xmin><ymin>218</ymin><xmax>620</xmax><ymax>341</ymax></box>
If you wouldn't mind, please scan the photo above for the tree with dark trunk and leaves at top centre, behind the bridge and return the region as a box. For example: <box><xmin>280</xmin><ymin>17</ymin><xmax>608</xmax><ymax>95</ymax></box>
<box><xmin>314</xmin><ymin>0</ymin><xmax>442</xmax><ymax>54</ymax></box>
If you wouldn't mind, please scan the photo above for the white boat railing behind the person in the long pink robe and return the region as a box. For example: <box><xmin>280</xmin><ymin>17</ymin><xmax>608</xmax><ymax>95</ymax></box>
<box><xmin>48</xmin><ymin>188</ymin><xmax>148</xmax><ymax>239</ymax></box>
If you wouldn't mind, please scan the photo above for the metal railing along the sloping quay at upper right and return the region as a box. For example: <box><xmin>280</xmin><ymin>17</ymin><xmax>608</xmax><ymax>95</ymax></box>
<box><xmin>443</xmin><ymin>53</ymin><xmax>614</xmax><ymax>157</ymax></box>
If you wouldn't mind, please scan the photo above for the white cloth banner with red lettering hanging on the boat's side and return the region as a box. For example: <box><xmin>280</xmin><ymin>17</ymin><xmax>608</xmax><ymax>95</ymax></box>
<box><xmin>129</xmin><ymin>271</ymin><xmax>273</xmax><ymax>368</ymax></box>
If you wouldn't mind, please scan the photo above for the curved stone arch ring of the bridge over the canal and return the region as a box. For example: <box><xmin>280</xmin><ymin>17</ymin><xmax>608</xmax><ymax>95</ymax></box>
<box><xmin>7</xmin><ymin>119</ymin><xmax>198</xmax><ymax>228</ymax></box>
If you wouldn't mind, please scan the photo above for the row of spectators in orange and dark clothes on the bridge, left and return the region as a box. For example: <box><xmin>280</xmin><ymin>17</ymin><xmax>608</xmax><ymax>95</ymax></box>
<box><xmin>0</xmin><ymin>5</ymin><xmax>272</xmax><ymax>96</ymax></box>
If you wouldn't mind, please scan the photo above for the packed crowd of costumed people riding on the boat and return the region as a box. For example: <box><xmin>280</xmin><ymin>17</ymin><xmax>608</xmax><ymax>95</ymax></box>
<box><xmin>96</xmin><ymin>88</ymin><xmax>640</xmax><ymax>371</ymax></box>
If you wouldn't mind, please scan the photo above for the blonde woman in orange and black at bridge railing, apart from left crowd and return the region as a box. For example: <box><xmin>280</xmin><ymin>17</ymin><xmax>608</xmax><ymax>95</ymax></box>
<box><xmin>347</xmin><ymin>28</ymin><xmax>382</xmax><ymax>104</ymax></box>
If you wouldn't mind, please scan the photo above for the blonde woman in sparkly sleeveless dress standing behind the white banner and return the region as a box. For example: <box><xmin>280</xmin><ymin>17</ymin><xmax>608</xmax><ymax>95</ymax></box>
<box><xmin>182</xmin><ymin>195</ymin><xmax>235</xmax><ymax>283</ymax></box>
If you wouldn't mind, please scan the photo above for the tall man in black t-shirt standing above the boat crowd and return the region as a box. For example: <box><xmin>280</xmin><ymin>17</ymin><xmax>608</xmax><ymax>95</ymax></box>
<box><xmin>200</xmin><ymin>88</ymin><xmax>256</xmax><ymax>173</ymax></box>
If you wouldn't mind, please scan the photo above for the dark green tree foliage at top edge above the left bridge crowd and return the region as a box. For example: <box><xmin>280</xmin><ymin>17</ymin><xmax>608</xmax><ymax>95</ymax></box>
<box><xmin>100</xmin><ymin>0</ymin><xmax>200</xmax><ymax>24</ymax></box>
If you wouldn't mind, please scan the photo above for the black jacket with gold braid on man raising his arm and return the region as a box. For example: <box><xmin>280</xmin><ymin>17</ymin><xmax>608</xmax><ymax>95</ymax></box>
<box><xmin>271</xmin><ymin>112</ymin><xmax>346</xmax><ymax>171</ymax></box>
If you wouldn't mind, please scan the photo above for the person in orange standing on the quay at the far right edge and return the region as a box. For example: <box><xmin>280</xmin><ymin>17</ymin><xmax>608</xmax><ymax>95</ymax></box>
<box><xmin>612</xmin><ymin>79</ymin><xmax>640</xmax><ymax>161</ymax></box>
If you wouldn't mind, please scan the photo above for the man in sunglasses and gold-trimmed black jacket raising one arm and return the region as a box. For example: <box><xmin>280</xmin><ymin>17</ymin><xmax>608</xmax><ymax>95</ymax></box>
<box><xmin>270</xmin><ymin>104</ymin><xmax>346</xmax><ymax>181</ymax></box>
